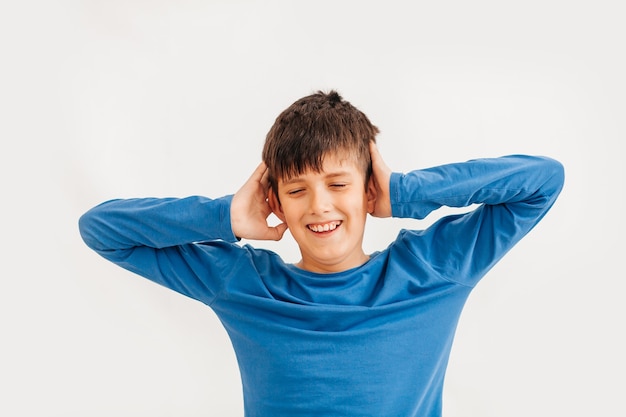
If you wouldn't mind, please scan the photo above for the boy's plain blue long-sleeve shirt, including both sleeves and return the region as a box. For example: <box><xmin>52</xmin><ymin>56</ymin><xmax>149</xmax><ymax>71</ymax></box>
<box><xmin>80</xmin><ymin>155</ymin><xmax>564</xmax><ymax>417</ymax></box>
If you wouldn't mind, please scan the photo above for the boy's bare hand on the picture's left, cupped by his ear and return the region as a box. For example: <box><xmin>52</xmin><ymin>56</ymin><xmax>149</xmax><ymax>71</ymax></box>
<box><xmin>230</xmin><ymin>162</ymin><xmax>287</xmax><ymax>240</ymax></box>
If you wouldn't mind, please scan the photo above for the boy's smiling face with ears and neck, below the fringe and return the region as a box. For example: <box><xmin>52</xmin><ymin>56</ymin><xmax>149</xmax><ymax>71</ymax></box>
<box><xmin>269</xmin><ymin>155</ymin><xmax>376</xmax><ymax>273</ymax></box>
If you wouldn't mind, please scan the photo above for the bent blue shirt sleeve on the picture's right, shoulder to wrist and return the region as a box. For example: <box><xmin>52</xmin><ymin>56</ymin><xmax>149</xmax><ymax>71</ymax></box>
<box><xmin>390</xmin><ymin>155</ymin><xmax>564</xmax><ymax>286</ymax></box>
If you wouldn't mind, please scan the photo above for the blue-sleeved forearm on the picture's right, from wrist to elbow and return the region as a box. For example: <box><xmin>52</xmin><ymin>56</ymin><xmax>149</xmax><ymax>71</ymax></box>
<box><xmin>389</xmin><ymin>155</ymin><xmax>564</xmax><ymax>223</ymax></box>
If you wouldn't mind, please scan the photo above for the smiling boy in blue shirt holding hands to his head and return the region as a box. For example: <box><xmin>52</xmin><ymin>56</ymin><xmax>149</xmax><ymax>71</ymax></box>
<box><xmin>80</xmin><ymin>91</ymin><xmax>563</xmax><ymax>417</ymax></box>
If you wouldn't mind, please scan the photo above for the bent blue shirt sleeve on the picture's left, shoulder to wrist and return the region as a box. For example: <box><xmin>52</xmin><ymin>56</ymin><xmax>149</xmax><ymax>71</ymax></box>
<box><xmin>79</xmin><ymin>196</ymin><xmax>243</xmax><ymax>304</ymax></box>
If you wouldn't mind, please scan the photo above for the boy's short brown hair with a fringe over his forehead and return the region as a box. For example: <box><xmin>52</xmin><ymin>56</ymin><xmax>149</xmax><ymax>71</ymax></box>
<box><xmin>263</xmin><ymin>90</ymin><xmax>379</xmax><ymax>193</ymax></box>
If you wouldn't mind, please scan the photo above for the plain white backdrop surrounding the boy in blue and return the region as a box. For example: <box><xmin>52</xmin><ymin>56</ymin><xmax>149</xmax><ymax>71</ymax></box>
<box><xmin>0</xmin><ymin>0</ymin><xmax>626</xmax><ymax>417</ymax></box>
